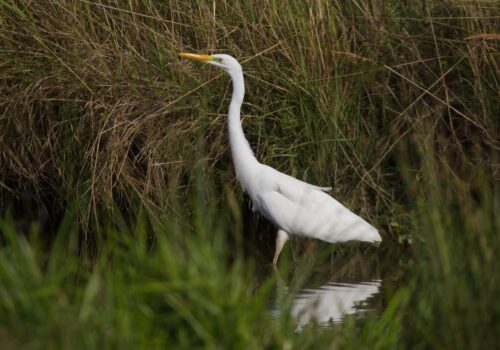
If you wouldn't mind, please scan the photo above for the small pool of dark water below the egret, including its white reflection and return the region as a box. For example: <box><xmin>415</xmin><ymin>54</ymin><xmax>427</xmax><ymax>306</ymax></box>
<box><xmin>252</xmin><ymin>242</ymin><xmax>405</xmax><ymax>331</ymax></box>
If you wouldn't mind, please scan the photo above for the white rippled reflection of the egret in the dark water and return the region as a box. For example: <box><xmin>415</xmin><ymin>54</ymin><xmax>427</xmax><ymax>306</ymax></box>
<box><xmin>273</xmin><ymin>280</ymin><xmax>381</xmax><ymax>330</ymax></box>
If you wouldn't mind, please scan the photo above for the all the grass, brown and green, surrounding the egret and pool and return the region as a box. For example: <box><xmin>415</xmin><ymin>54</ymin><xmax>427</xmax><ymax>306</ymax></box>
<box><xmin>0</xmin><ymin>0</ymin><xmax>500</xmax><ymax>349</ymax></box>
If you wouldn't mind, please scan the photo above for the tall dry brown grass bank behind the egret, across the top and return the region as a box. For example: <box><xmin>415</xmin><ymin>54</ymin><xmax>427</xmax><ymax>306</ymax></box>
<box><xmin>0</xmin><ymin>0</ymin><xmax>500</xmax><ymax>235</ymax></box>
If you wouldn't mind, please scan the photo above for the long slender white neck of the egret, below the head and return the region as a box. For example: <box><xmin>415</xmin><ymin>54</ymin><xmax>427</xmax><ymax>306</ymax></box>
<box><xmin>228</xmin><ymin>70</ymin><xmax>258</xmax><ymax>189</ymax></box>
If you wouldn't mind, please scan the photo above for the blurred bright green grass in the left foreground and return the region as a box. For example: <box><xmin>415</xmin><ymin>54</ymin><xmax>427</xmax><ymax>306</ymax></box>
<box><xmin>0</xmin><ymin>190</ymin><xmax>401</xmax><ymax>349</ymax></box>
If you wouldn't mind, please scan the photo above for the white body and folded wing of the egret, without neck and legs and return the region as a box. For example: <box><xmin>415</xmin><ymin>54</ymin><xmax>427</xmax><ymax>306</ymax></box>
<box><xmin>257</xmin><ymin>168</ymin><xmax>381</xmax><ymax>242</ymax></box>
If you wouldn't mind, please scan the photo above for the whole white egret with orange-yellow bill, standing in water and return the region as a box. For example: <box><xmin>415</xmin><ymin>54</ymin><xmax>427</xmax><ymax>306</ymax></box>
<box><xmin>179</xmin><ymin>53</ymin><xmax>382</xmax><ymax>265</ymax></box>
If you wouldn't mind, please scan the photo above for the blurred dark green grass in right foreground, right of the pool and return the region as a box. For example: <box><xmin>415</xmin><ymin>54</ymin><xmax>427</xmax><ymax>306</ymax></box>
<box><xmin>405</xmin><ymin>160</ymin><xmax>500</xmax><ymax>349</ymax></box>
